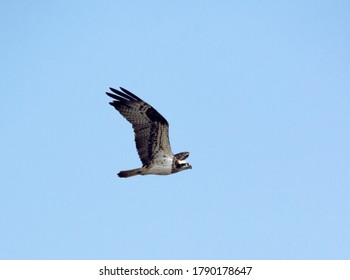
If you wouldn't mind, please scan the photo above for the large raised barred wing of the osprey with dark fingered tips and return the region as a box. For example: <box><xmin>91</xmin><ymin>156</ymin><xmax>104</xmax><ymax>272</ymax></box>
<box><xmin>106</xmin><ymin>87</ymin><xmax>173</xmax><ymax>165</ymax></box>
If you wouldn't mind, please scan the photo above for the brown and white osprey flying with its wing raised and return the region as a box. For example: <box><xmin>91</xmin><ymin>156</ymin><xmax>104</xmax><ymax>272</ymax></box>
<box><xmin>106</xmin><ymin>87</ymin><xmax>192</xmax><ymax>178</ymax></box>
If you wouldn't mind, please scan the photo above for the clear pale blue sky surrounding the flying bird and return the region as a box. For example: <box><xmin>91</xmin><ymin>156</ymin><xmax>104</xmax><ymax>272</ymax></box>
<box><xmin>0</xmin><ymin>0</ymin><xmax>350</xmax><ymax>259</ymax></box>
